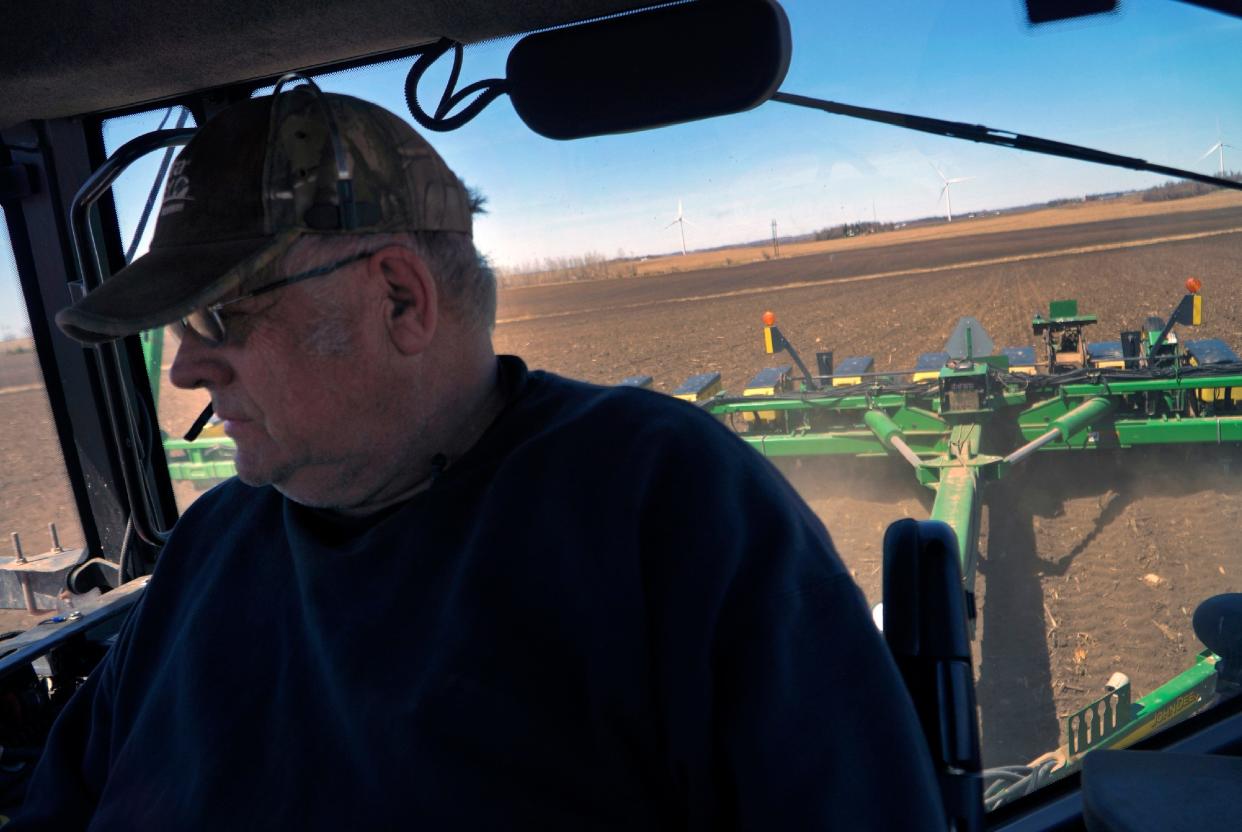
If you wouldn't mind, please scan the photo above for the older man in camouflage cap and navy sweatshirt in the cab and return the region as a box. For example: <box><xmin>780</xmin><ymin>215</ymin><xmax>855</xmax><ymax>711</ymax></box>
<box><xmin>12</xmin><ymin>86</ymin><xmax>943</xmax><ymax>830</ymax></box>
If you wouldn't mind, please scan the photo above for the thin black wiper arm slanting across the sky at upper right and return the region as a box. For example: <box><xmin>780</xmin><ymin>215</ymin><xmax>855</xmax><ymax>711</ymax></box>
<box><xmin>771</xmin><ymin>92</ymin><xmax>1242</xmax><ymax>190</ymax></box>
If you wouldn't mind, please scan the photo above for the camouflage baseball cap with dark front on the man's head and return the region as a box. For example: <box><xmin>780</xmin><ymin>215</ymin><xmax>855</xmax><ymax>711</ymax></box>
<box><xmin>56</xmin><ymin>86</ymin><xmax>471</xmax><ymax>343</ymax></box>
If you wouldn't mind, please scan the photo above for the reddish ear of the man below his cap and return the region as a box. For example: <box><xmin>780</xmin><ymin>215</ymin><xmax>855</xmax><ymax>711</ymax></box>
<box><xmin>366</xmin><ymin>246</ymin><xmax>440</xmax><ymax>355</ymax></box>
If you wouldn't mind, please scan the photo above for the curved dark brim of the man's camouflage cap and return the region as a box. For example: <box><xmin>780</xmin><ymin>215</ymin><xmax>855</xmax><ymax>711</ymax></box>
<box><xmin>56</xmin><ymin>235</ymin><xmax>288</xmax><ymax>344</ymax></box>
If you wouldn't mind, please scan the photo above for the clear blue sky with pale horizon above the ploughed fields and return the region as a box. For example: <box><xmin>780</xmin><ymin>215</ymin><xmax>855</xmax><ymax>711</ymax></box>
<box><xmin>0</xmin><ymin>0</ymin><xmax>1242</xmax><ymax>334</ymax></box>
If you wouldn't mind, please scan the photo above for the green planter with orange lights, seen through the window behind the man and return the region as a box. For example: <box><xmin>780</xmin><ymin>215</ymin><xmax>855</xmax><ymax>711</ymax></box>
<box><xmin>676</xmin><ymin>278</ymin><xmax>1242</xmax><ymax>807</ymax></box>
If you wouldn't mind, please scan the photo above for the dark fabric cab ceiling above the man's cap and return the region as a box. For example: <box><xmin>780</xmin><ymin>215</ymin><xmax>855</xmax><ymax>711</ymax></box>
<box><xmin>0</xmin><ymin>0</ymin><xmax>652</xmax><ymax>129</ymax></box>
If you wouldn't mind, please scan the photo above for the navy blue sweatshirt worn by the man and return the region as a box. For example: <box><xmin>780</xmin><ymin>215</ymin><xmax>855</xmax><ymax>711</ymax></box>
<box><xmin>11</xmin><ymin>359</ymin><xmax>939</xmax><ymax>831</ymax></box>
